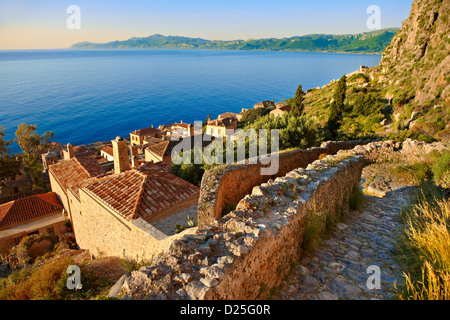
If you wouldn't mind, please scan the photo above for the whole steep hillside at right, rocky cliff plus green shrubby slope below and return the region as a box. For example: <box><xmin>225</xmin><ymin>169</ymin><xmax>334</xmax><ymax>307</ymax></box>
<box><xmin>300</xmin><ymin>0</ymin><xmax>450</xmax><ymax>142</ymax></box>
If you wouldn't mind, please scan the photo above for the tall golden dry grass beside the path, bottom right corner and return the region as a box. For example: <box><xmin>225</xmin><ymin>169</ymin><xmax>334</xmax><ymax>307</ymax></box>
<box><xmin>399</xmin><ymin>195</ymin><xmax>450</xmax><ymax>300</ymax></box>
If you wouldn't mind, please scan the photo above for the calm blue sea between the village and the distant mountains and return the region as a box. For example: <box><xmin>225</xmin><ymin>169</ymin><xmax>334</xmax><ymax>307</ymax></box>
<box><xmin>0</xmin><ymin>50</ymin><xmax>380</xmax><ymax>151</ymax></box>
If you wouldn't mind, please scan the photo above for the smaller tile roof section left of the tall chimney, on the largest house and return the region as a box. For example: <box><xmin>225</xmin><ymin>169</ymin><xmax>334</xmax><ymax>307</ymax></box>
<box><xmin>49</xmin><ymin>156</ymin><xmax>105</xmax><ymax>195</ymax></box>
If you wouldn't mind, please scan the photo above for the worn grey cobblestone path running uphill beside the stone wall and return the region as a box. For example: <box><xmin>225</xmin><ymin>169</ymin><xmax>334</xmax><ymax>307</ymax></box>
<box><xmin>274</xmin><ymin>168</ymin><xmax>414</xmax><ymax>300</ymax></box>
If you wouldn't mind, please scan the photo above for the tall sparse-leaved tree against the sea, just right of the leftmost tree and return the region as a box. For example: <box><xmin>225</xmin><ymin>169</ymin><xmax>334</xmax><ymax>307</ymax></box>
<box><xmin>14</xmin><ymin>123</ymin><xmax>54</xmax><ymax>187</ymax></box>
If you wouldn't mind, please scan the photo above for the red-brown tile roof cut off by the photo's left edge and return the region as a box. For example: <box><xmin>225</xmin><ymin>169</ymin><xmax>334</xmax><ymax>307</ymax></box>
<box><xmin>0</xmin><ymin>192</ymin><xmax>63</xmax><ymax>228</ymax></box>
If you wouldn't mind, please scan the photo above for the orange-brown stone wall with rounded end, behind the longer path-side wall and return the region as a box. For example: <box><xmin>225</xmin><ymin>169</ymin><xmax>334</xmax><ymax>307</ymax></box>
<box><xmin>198</xmin><ymin>140</ymin><xmax>370</xmax><ymax>227</ymax></box>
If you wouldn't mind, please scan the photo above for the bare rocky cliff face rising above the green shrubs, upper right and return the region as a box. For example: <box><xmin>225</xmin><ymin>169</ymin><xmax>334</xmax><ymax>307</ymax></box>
<box><xmin>376</xmin><ymin>0</ymin><xmax>450</xmax><ymax>112</ymax></box>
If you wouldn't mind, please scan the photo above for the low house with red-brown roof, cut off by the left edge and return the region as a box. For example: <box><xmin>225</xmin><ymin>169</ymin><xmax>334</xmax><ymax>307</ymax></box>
<box><xmin>0</xmin><ymin>192</ymin><xmax>67</xmax><ymax>255</ymax></box>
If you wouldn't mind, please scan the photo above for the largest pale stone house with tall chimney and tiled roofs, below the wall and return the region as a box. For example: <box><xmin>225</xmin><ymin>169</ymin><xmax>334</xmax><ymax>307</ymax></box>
<box><xmin>49</xmin><ymin>137</ymin><xmax>199</xmax><ymax>260</ymax></box>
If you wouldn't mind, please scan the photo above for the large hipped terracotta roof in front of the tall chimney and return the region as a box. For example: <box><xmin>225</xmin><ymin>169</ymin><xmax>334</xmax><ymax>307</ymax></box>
<box><xmin>82</xmin><ymin>162</ymin><xmax>200</xmax><ymax>221</ymax></box>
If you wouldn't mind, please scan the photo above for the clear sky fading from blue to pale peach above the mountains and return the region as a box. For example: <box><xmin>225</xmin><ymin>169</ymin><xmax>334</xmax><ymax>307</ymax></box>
<box><xmin>0</xmin><ymin>0</ymin><xmax>412</xmax><ymax>50</ymax></box>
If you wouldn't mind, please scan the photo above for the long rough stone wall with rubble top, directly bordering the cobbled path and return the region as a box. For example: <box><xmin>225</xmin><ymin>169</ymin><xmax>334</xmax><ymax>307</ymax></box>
<box><xmin>112</xmin><ymin>150</ymin><xmax>364</xmax><ymax>300</ymax></box>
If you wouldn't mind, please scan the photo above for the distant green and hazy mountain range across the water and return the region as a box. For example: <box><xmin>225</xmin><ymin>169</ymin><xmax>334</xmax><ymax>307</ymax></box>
<box><xmin>71</xmin><ymin>28</ymin><xmax>399</xmax><ymax>54</ymax></box>
